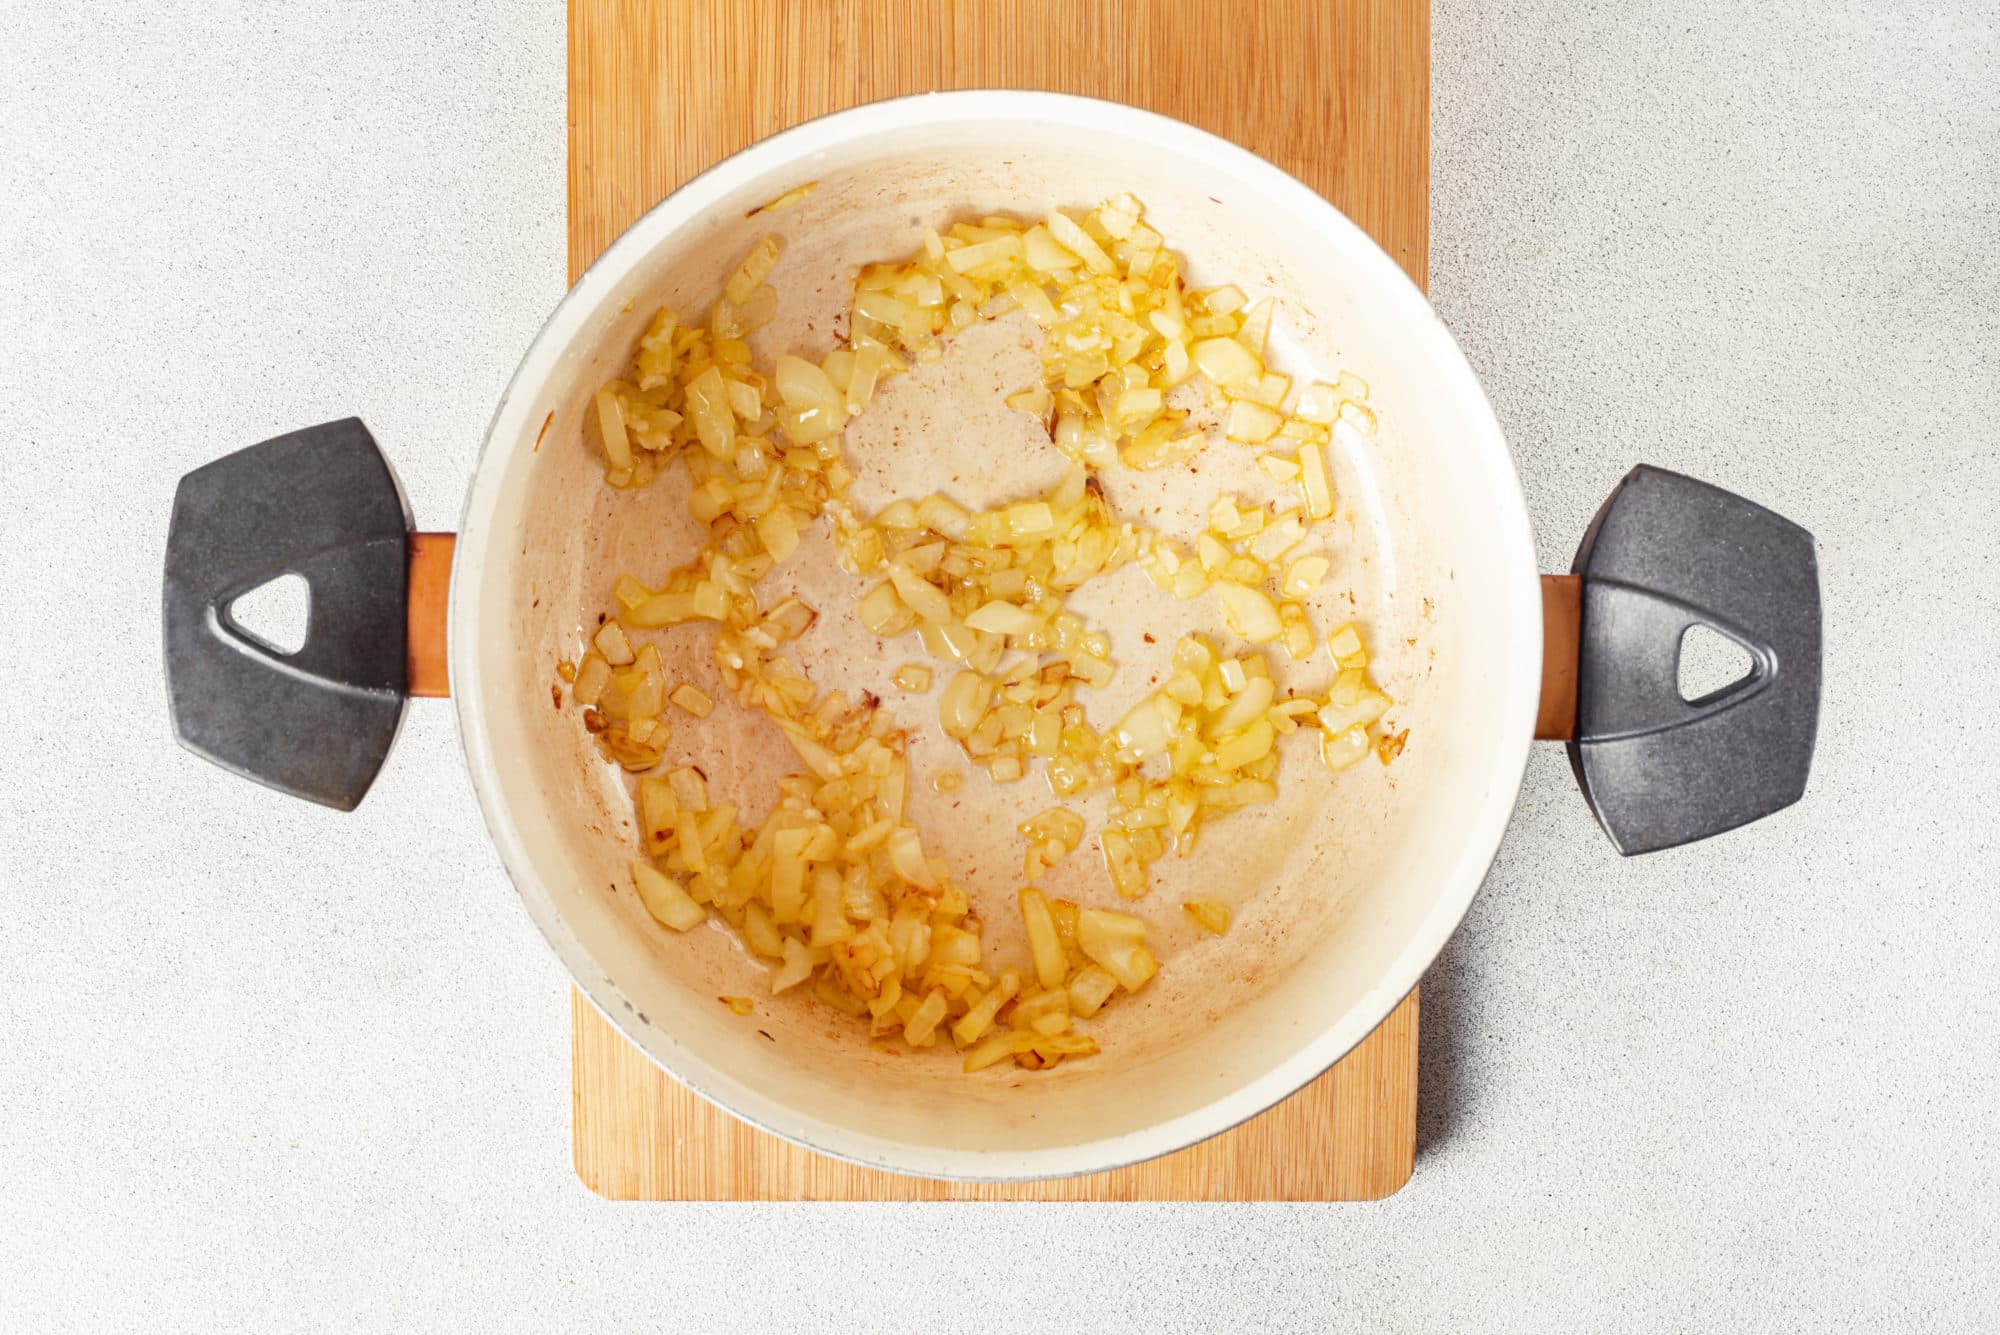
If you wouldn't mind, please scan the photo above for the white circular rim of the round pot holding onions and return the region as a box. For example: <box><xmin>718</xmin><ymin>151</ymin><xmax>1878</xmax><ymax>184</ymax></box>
<box><xmin>448</xmin><ymin>90</ymin><xmax>1542</xmax><ymax>1181</ymax></box>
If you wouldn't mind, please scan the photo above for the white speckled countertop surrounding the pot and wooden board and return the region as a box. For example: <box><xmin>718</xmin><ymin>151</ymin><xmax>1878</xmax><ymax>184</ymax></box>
<box><xmin>0</xmin><ymin>0</ymin><xmax>2000</xmax><ymax>1331</ymax></box>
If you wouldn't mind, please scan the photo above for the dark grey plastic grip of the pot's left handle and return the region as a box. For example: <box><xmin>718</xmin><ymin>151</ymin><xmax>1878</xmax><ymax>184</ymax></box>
<box><xmin>164</xmin><ymin>418</ymin><xmax>410</xmax><ymax>811</ymax></box>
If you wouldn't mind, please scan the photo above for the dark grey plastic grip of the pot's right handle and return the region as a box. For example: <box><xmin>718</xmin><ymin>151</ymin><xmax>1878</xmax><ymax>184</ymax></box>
<box><xmin>1570</xmin><ymin>466</ymin><xmax>1820</xmax><ymax>855</ymax></box>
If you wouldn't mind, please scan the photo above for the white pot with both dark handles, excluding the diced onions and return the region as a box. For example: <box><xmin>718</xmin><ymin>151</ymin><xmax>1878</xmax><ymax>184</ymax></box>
<box><xmin>166</xmin><ymin>92</ymin><xmax>1818</xmax><ymax>1179</ymax></box>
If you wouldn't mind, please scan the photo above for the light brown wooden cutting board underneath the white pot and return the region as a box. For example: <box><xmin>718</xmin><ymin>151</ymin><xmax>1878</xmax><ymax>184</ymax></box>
<box><xmin>570</xmin><ymin>0</ymin><xmax>1430</xmax><ymax>1201</ymax></box>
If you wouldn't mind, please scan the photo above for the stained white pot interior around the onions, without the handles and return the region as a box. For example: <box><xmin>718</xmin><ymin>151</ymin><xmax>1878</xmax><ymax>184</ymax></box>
<box><xmin>454</xmin><ymin>100</ymin><xmax>1540</xmax><ymax>1175</ymax></box>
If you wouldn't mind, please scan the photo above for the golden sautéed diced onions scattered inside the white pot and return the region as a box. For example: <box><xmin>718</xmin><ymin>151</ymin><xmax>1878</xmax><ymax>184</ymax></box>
<box><xmin>558</xmin><ymin>184</ymin><xmax>1408</xmax><ymax>1069</ymax></box>
